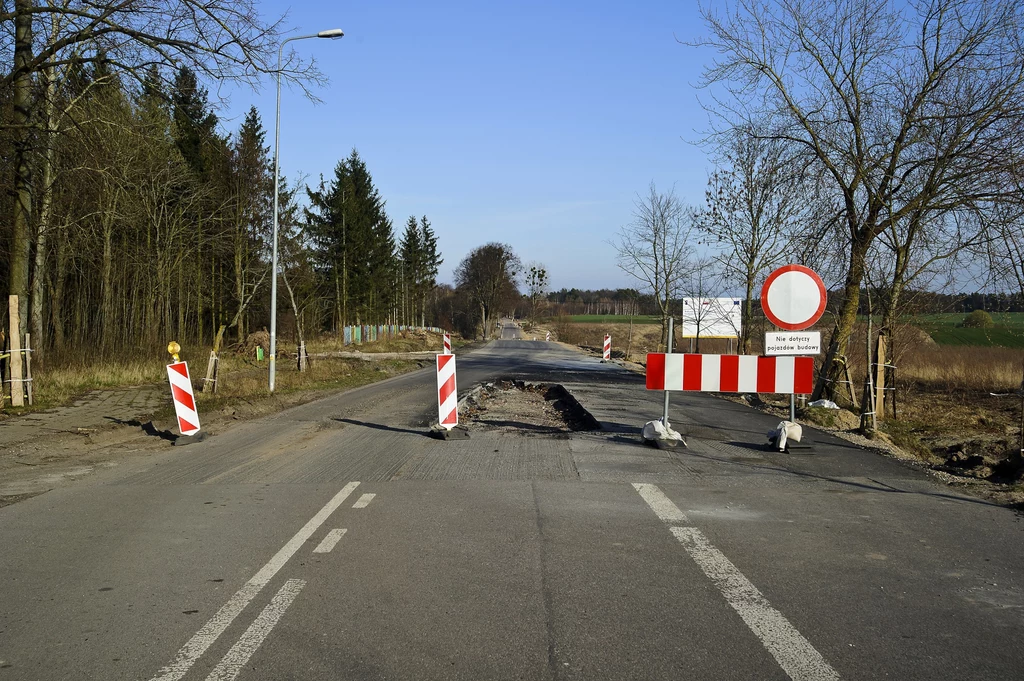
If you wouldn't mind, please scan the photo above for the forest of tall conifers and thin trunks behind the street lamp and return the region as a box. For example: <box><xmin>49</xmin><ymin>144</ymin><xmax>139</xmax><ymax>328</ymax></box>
<box><xmin>0</xmin><ymin>61</ymin><xmax>441</xmax><ymax>355</ymax></box>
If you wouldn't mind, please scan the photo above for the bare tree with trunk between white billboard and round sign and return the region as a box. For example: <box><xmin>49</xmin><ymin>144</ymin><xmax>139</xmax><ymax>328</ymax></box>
<box><xmin>696</xmin><ymin>129</ymin><xmax>812</xmax><ymax>353</ymax></box>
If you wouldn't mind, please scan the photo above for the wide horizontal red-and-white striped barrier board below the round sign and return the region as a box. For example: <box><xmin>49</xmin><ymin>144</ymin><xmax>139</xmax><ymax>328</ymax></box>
<box><xmin>647</xmin><ymin>352</ymin><xmax>814</xmax><ymax>394</ymax></box>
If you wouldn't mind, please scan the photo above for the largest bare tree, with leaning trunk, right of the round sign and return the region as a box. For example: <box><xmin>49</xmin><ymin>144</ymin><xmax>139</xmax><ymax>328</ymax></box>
<box><xmin>697</xmin><ymin>0</ymin><xmax>1024</xmax><ymax>396</ymax></box>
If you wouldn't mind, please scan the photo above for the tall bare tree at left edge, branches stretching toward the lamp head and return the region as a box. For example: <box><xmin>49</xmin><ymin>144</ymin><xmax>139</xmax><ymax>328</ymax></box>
<box><xmin>0</xmin><ymin>0</ymin><xmax>323</xmax><ymax>339</ymax></box>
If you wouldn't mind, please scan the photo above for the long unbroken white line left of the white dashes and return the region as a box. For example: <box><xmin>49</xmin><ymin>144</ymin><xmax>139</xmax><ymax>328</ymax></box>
<box><xmin>150</xmin><ymin>482</ymin><xmax>359</xmax><ymax>681</ymax></box>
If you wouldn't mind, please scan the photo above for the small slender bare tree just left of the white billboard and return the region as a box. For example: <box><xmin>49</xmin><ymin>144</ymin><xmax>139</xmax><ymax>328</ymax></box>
<box><xmin>611</xmin><ymin>182</ymin><xmax>694</xmax><ymax>344</ymax></box>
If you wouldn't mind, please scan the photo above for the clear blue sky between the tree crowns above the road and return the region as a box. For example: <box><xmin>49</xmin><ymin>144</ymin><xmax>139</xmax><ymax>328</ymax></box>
<box><xmin>221</xmin><ymin>0</ymin><xmax>710</xmax><ymax>290</ymax></box>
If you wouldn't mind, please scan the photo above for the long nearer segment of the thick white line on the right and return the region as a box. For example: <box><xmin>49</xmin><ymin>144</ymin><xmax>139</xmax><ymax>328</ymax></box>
<box><xmin>671</xmin><ymin>524</ymin><xmax>840</xmax><ymax>681</ymax></box>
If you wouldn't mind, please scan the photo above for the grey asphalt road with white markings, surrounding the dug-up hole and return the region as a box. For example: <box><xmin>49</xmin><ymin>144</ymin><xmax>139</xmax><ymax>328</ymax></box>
<box><xmin>0</xmin><ymin>341</ymin><xmax>1024</xmax><ymax>681</ymax></box>
